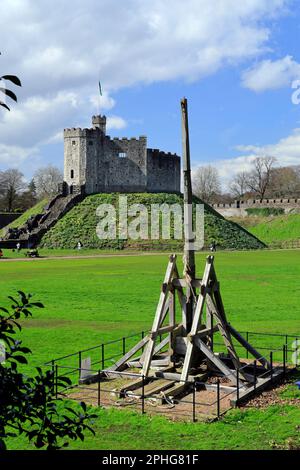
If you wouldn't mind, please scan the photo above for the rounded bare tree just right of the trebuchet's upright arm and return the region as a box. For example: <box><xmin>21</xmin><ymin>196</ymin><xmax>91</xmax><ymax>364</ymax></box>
<box><xmin>193</xmin><ymin>165</ymin><xmax>221</xmax><ymax>204</ymax></box>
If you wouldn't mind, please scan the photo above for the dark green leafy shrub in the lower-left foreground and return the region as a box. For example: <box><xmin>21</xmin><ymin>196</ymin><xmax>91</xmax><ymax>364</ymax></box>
<box><xmin>0</xmin><ymin>291</ymin><xmax>96</xmax><ymax>450</ymax></box>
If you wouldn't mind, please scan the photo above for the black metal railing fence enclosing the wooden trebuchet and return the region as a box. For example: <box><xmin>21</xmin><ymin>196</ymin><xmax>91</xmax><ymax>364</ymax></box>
<box><xmin>46</xmin><ymin>331</ymin><xmax>300</xmax><ymax>422</ymax></box>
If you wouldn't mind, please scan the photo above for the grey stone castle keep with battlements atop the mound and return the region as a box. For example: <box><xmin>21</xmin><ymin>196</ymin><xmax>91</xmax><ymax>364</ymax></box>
<box><xmin>63</xmin><ymin>116</ymin><xmax>180</xmax><ymax>194</ymax></box>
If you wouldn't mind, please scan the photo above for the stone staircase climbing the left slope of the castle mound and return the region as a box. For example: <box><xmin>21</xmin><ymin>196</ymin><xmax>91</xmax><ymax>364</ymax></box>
<box><xmin>0</xmin><ymin>194</ymin><xmax>84</xmax><ymax>248</ymax></box>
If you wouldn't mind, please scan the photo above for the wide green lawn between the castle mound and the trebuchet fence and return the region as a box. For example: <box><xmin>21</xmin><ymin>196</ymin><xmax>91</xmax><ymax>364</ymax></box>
<box><xmin>0</xmin><ymin>250</ymin><xmax>300</xmax><ymax>363</ymax></box>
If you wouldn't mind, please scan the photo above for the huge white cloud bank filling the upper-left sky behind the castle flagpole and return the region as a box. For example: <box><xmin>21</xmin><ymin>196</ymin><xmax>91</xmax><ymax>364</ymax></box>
<box><xmin>0</xmin><ymin>0</ymin><xmax>289</xmax><ymax>173</ymax></box>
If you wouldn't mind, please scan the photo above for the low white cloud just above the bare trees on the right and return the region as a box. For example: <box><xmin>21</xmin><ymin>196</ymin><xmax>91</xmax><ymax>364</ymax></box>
<box><xmin>196</xmin><ymin>128</ymin><xmax>300</xmax><ymax>189</ymax></box>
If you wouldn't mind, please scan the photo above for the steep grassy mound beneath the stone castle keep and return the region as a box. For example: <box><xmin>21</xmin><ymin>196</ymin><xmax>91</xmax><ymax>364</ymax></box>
<box><xmin>40</xmin><ymin>193</ymin><xmax>264</xmax><ymax>250</ymax></box>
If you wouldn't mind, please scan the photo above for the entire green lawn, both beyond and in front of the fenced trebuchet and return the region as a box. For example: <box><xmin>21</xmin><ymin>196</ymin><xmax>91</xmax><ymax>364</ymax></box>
<box><xmin>0</xmin><ymin>250</ymin><xmax>300</xmax><ymax>449</ymax></box>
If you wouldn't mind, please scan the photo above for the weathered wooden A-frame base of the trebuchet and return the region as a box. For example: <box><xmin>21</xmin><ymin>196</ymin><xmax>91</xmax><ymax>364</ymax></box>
<box><xmin>105</xmin><ymin>255</ymin><xmax>269</xmax><ymax>396</ymax></box>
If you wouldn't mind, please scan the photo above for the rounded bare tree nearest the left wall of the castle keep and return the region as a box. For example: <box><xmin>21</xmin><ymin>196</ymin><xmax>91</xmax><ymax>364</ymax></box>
<box><xmin>34</xmin><ymin>165</ymin><xmax>63</xmax><ymax>198</ymax></box>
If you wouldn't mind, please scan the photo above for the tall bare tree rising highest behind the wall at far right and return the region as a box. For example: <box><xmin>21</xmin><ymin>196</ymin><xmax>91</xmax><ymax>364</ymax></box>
<box><xmin>247</xmin><ymin>156</ymin><xmax>276</xmax><ymax>199</ymax></box>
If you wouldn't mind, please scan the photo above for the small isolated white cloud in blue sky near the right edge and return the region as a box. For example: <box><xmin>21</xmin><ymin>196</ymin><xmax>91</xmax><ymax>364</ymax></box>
<box><xmin>242</xmin><ymin>55</ymin><xmax>300</xmax><ymax>92</ymax></box>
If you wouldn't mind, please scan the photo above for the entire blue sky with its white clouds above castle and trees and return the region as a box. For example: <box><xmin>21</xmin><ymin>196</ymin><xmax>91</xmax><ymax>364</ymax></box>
<box><xmin>0</xmin><ymin>0</ymin><xmax>300</xmax><ymax>189</ymax></box>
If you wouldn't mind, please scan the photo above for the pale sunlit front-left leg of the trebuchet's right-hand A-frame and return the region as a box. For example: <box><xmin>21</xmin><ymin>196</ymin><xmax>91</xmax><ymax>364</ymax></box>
<box><xmin>181</xmin><ymin>256</ymin><xmax>214</xmax><ymax>382</ymax></box>
